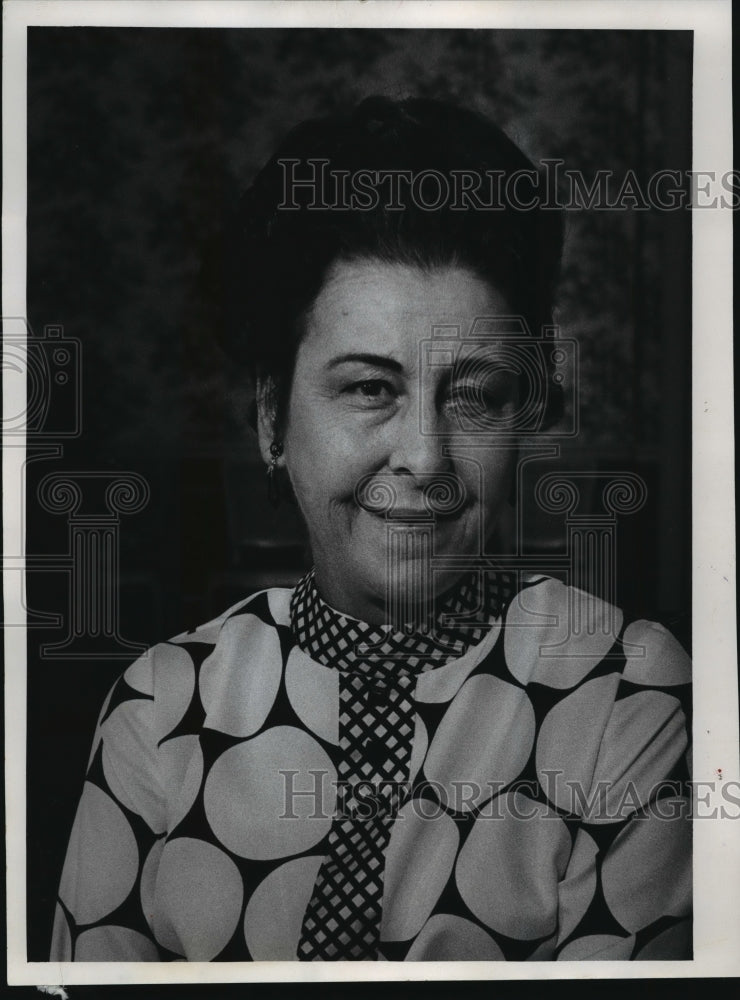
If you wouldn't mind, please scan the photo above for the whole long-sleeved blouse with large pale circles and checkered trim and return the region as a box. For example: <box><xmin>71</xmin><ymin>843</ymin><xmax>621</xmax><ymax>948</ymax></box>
<box><xmin>51</xmin><ymin>574</ymin><xmax>691</xmax><ymax>961</ymax></box>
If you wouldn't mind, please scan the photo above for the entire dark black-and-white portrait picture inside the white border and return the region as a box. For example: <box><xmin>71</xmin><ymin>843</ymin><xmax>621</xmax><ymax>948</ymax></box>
<box><xmin>3</xmin><ymin>5</ymin><xmax>737</xmax><ymax>974</ymax></box>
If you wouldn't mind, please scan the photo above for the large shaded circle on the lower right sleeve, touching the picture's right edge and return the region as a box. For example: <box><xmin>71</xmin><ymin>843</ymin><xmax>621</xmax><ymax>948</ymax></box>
<box><xmin>601</xmin><ymin>799</ymin><xmax>691</xmax><ymax>931</ymax></box>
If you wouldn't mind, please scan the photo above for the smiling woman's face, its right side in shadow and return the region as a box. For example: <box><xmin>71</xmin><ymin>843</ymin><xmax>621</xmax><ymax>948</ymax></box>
<box><xmin>261</xmin><ymin>260</ymin><xmax>517</xmax><ymax>624</ymax></box>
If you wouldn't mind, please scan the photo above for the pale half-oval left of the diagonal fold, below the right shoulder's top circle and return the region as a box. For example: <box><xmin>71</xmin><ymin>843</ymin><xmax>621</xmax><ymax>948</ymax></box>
<box><xmin>536</xmin><ymin>674</ymin><xmax>619</xmax><ymax>815</ymax></box>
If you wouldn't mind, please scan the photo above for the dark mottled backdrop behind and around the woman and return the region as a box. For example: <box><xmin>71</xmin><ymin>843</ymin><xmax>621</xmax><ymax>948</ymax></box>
<box><xmin>27</xmin><ymin>28</ymin><xmax>691</xmax><ymax>960</ymax></box>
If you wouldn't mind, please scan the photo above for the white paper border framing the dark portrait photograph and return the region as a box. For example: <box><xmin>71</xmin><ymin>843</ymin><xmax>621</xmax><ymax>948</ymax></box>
<box><xmin>2</xmin><ymin>0</ymin><xmax>740</xmax><ymax>985</ymax></box>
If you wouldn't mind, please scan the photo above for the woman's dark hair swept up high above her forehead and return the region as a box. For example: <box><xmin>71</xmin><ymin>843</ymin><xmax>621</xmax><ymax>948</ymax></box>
<box><xmin>214</xmin><ymin>97</ymin><xmax>563</xmax><ymax>427</ymax></box>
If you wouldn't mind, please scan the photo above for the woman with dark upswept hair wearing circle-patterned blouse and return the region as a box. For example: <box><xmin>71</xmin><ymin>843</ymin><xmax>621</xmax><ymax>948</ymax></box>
<box><xmin>52</xmin><ymin>98</ymin><xmax>690</xmax><ymax>961</ymax></box>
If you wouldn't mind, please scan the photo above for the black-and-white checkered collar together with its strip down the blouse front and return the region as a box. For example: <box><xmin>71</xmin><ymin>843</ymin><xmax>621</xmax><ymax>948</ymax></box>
<box><xmin>291</xmin><ymin>571</ymin><xmax>513</xmax><ymax>961</ymax></box>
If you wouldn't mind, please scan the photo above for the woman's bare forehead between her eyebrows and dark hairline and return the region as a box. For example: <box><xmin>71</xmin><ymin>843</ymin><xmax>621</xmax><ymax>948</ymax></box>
<box><xmin>300</xmin><ymin>260</ymin><xmax>510</xmax><ymax>363</ymax></box>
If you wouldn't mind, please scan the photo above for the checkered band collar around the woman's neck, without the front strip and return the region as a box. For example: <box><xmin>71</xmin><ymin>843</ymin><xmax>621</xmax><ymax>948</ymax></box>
<box><xmin>290</xmin><ymin>570</ymin><xmax>514</xmax><ymax>674</ymax></box>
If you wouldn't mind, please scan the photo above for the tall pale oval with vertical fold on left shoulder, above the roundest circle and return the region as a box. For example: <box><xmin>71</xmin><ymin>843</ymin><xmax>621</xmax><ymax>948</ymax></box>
<box><xmin>198</xmin><ymin>614</ymin><xmax>283</xmax><ymax>736</ymax></box>
